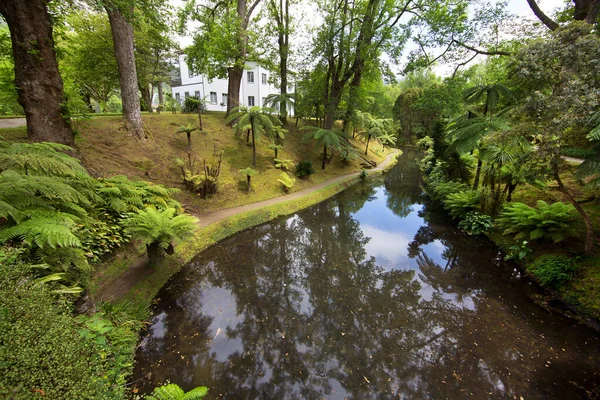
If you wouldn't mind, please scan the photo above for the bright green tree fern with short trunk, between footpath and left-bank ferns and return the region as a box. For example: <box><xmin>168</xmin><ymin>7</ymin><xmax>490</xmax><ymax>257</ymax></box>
<box><xmin>125</xmin><ymin>207</ymin><xmax>198</xmax><ymax>265</ymax></box>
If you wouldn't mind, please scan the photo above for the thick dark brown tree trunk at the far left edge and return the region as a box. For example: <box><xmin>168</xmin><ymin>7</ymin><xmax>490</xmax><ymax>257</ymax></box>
<box><xmin>0</xmin><ymin>0</ymin><xmax>74</xmax><ymax>146</ymax></box>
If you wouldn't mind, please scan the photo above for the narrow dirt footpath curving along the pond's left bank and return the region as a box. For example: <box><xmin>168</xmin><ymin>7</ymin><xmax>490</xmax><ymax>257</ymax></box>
<box><xmin>94</xmin><ymin>151</ymin><xmax>400</xmax><ymax>302</ymax></box>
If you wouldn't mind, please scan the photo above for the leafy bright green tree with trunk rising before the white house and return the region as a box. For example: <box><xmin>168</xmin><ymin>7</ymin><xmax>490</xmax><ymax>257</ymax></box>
<box><xmin>182</xmin><ymin>0</ymin><xmax>260</xmax><ymax>116</ymax></box>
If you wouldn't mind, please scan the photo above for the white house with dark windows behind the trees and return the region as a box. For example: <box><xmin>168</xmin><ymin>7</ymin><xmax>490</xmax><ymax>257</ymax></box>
<box><xmin>171</xmin><ymin>54</ymin><xmax>279</xmax><ymax>111</ymax></box>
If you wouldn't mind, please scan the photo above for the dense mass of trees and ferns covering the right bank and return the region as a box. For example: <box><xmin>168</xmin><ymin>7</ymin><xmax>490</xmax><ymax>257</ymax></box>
<box><xmin>404</xmin><ymin>22</ymin><xmax>600</xmax><ymax>318</ymax></box>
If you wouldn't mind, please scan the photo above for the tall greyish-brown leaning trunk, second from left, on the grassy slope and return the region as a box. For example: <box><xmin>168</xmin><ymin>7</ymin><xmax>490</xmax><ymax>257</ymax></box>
<box><xmin>104</xmin><ymin>3</ymin><xmax>146</xmax><ymax>140</ymax></box>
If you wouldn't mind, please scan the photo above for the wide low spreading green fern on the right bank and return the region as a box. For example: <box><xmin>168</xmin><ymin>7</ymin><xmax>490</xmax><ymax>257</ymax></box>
<box><xmin>496</xmin><ymin>200</ymin><xmax>577</xmax><ymax>243</ymax></box>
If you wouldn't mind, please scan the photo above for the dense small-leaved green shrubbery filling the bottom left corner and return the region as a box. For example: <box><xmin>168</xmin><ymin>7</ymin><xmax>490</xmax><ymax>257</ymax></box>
<box><xmin>0</xmin><ymin>260</ymin><xmax>127</xmax><ymax>399</ymax></box>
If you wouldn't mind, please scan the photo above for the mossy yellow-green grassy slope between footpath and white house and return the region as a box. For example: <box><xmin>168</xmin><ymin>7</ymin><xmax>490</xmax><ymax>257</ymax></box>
<box><xmin>61</xmin><ymin>113</ymin><xmax>383</xmax><ymax>216</ymax></box>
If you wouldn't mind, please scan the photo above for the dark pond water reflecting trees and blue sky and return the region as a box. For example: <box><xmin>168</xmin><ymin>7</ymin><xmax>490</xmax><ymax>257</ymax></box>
<box><xmin>135</xmin><ymin>153</ymin><xmax>600</xmax><ymax>400</ymax></box>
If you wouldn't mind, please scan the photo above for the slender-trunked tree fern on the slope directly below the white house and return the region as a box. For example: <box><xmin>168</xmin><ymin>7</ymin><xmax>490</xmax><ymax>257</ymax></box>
<box><xmin>227</xmin><ymin>106</ymin><xmax>281</xmax><ymax>168</ymax></box>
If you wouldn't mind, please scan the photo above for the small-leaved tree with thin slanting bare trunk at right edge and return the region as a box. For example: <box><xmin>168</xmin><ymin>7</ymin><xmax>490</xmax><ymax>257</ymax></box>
<box><xmin>511</xmin><ymin>22</ymin><xmax>600</xmax><ymax>253</ymax></box>
